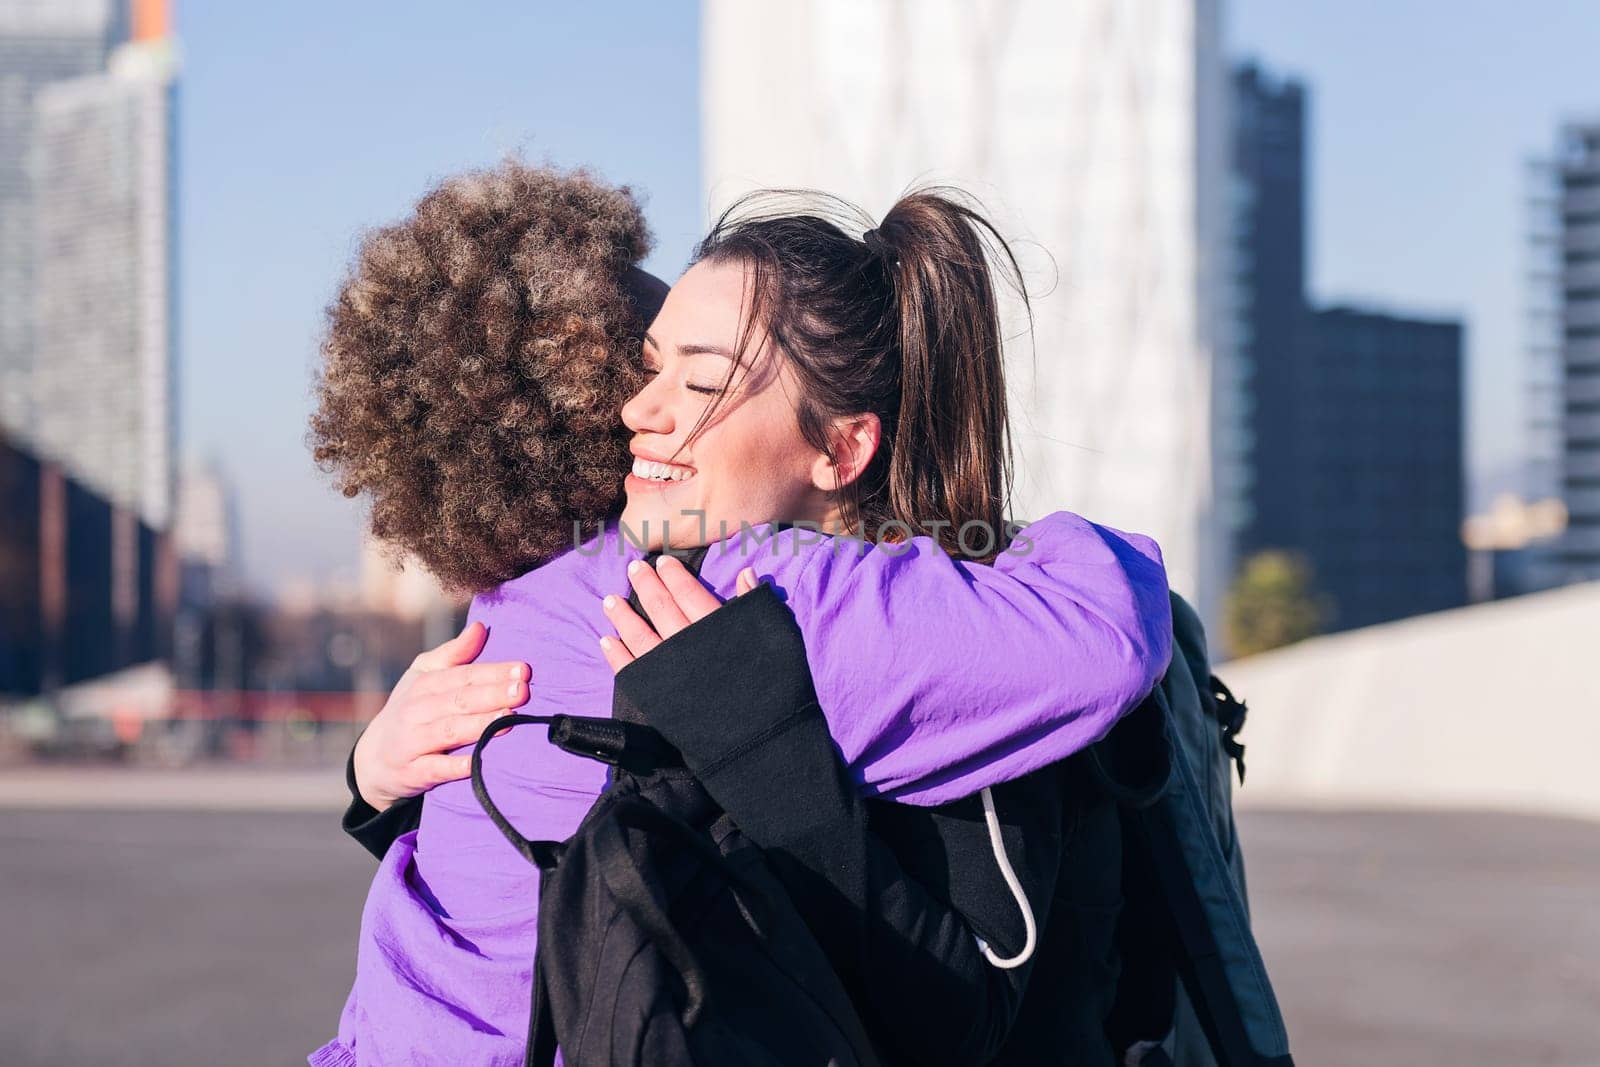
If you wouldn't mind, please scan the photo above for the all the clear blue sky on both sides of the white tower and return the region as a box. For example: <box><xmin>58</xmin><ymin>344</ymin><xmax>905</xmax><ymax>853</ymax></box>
<box><xmin>179</xmin><ymin>0</ymin><xmax>1600</xmax><ymax>585</ymax></box>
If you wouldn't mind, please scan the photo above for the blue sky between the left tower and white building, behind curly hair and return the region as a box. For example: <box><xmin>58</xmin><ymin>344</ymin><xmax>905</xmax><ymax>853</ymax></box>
<box><xmin>179</xmin><ymin>0</ymin><xmax>702</xmax><ymax>585</ymax></box>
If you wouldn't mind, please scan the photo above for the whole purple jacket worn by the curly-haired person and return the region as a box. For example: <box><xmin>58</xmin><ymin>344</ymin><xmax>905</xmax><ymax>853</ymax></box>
<box><xmin>309</xmin><ymin>512</ymin><xmax>1171</xmax><ymax>1067</ymax></box>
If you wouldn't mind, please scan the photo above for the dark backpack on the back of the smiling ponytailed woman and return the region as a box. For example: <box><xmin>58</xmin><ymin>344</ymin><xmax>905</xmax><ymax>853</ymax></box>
<box><xmin>1088</xmin><ymin>593</ymin><xmax>1294</xmax><ymax>1067</ymax></box>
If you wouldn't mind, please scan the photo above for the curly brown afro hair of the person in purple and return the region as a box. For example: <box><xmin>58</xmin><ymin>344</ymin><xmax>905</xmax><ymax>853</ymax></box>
<box><xmin>310</xmin><ymin>160</ymin><xmax>651</xmax><ymax>592</ymax></box>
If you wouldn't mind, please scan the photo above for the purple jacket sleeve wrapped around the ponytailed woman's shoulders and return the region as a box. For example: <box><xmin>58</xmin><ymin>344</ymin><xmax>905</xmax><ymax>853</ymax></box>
<box><xmin>701</xmin><ymin>512</ymin><xmax>1171</xmax><ymax>806</ymax></box>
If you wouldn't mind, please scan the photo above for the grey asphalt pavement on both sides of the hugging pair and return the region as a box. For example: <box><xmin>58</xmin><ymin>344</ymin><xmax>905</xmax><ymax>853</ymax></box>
<box><xmin>0</xmin><ymin>809</ymin><xmax>1600</xmax><ymax>1067</ymax></box>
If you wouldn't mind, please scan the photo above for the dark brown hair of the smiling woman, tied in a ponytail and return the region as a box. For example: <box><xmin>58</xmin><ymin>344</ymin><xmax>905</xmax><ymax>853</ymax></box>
<box><xmin>696</xmin><ymin>190</ymin><xmax>1026</xmax><ymax>558</ymax></box>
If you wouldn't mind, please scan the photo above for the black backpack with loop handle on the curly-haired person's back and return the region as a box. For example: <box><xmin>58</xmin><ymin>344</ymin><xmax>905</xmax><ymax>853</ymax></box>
<box><xmin>472</xmin><ymin>715</ymin><xmax>877</xmax><ymax>1067</ymax></box>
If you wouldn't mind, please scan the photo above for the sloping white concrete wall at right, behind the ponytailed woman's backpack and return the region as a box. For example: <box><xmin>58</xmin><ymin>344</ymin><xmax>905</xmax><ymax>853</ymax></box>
<box><xmin>1218</xmin><ymin>582</ymin><xmax>1600</xmax><ymax>819</ymax></box>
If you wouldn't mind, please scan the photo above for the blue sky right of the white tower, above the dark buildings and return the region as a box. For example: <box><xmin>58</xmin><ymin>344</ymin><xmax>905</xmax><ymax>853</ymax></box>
<box><xmin>1229</xmin><ymin>0</ymin><xmax>1600</xmax><ymax>502</ymax></box>
